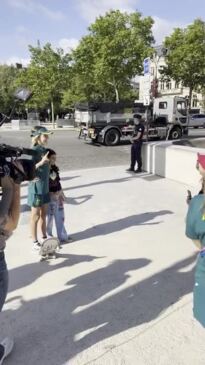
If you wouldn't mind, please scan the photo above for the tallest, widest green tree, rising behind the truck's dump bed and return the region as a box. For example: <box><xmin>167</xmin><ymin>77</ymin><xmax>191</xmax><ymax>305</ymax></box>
<box><xmin>67</xmin><ymin>10</ymin><xmax>154</xmax><ymax>101</ymax></box>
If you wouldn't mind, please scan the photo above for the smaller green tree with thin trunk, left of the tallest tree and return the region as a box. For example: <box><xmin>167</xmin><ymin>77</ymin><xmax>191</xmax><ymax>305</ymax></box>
<box><xmin>18</xmin><ymin>43</ymin><xmax>70</xmax><ymax>121</ymax></box>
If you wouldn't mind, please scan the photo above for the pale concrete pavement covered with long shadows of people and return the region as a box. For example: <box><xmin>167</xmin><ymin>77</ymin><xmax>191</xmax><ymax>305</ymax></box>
<box><xmin>0</xmin><ymin>166</ymin><xmax>205</xmax><ymax>365</ymax></box>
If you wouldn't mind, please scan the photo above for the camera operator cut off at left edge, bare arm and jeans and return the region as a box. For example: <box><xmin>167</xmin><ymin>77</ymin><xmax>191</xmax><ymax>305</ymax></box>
<box><xmin>0</xmin><ymin>161</ymin><xmax>23</xmax><ymax>365</ymax></box>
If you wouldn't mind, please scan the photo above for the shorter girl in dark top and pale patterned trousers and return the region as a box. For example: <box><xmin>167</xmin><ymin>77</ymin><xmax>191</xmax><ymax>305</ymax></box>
<box><xmin>47</xmin><ymin>149</ymin><xmax>73</xmax><ymax>243</ymax></box>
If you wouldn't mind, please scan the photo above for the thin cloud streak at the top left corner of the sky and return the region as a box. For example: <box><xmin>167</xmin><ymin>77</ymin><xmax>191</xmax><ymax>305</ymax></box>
<box><xmin>8</xmin><ymin>0</ymin><xmax>65</xmax><ymax>20</ymax></box>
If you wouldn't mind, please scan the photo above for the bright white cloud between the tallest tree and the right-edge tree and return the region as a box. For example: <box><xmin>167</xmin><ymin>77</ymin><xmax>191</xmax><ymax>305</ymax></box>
<box><xmin>152</xmin><ymin>16</ymin><xmax>185</xmax><ymax>44</ymax></box>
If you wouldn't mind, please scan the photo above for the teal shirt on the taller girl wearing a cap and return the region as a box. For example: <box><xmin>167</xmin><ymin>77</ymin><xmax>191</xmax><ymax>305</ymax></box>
<box><xmin>29</xmin><ymin>145</ymin><xmax>50</xmax><ymax>196</ymax></box>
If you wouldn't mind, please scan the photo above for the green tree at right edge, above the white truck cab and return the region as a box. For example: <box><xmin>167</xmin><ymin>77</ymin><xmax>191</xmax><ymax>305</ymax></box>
<box><xmin>162</xmin><ymin>19</ymin><xmax>205</xmax><ymax>107</ymax></box>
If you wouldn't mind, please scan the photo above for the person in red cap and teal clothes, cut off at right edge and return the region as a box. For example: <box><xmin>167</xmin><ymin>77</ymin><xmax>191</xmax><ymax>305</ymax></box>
<box><xmin>186</xmin><ymin>154</ymin><xmax>205</xmax><ymax>327</ymax></box>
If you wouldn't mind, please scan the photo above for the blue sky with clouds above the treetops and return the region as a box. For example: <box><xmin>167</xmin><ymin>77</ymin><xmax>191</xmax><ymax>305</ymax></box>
<box><xmin>0</xmin><ymin>0</ymin><xmax>205</xmax><ymax>65</ymax></box>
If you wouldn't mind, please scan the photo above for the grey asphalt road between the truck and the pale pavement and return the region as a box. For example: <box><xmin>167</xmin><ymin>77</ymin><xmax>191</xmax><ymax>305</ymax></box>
<box><xmin>0</xmin><ymin>130</ymin><xmax>130</xmax><ymax>171</ymax></box>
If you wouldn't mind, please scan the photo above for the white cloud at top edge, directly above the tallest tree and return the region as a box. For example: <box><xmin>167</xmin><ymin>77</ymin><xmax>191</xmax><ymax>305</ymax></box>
<box><xmin>76</xmin><ymin>0</ymin><xmax>139</xmax><ymax>23</ymax></box>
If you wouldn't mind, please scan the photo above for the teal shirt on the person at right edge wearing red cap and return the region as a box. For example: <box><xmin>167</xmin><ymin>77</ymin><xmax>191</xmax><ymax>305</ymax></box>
<box><xmin>186</xmin><ymin>194</ymin><xmax>205</xmax><ymax>247</ymax></box>
